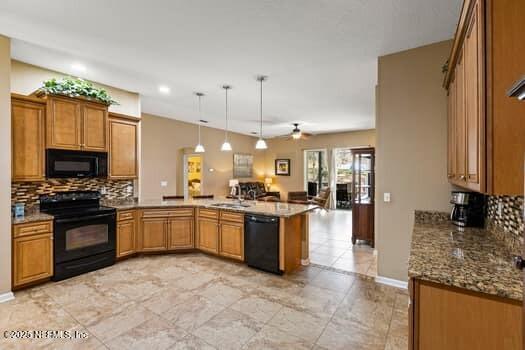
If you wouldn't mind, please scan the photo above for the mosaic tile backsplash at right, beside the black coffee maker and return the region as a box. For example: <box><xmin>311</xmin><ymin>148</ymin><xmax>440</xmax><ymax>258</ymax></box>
<box><xmin>487</xmin><ymin>196</ymin><xmax>524</xmax><ymax>253</ymax></box>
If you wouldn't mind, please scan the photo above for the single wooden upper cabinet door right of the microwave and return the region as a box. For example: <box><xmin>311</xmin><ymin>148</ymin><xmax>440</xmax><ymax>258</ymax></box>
<box><xmin>109</xmin><ymin>119</ymin><xmax>138</xmax><ymax>179</ymax></box>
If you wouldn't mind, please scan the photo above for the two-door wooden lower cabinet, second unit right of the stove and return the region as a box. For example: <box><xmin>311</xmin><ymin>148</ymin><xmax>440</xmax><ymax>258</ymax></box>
<box><xmin>138</xmin><ymin>208</ymin><xmax>195</xmax><ymax>252</ymax></box>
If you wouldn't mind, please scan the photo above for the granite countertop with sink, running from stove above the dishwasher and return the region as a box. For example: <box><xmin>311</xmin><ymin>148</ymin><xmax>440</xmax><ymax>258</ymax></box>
<box><xmin>103</xmin><ymin>197</ymin><xmax>318</xmax><ymax>218</ymax></box>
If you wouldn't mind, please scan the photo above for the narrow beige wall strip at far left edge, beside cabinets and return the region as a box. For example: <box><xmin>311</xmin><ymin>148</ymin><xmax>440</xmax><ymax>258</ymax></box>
<box><xmin>0</xmin><ymin>35</ymin><xmax>11</xmax><ymax>295</ymax></box>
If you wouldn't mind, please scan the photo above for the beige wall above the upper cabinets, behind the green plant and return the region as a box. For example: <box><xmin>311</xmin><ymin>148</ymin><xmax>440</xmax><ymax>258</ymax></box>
<box><xmin>11</xmin><ymin>60</ymin><xmax>140</xmax><ymax>117</ymax></box>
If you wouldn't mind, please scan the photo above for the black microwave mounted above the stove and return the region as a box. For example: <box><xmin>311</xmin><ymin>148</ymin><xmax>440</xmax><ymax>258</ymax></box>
<box><xmin>46</xmin><ymin>149</ymin><xmax>108</xmax><ymax>178</ymax></box>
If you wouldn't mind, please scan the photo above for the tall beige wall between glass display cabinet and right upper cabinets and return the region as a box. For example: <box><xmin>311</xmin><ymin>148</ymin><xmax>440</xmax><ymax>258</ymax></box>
<box><xmin>376</xmin><ymin>41</ymin><xmax>451</xmax><ymax>281</ymax></box>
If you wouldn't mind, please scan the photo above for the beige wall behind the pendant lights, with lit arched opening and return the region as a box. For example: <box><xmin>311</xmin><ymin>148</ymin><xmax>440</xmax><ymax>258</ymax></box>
<box><xmin>139</xmin><ymin>114</ymin><xmax>264</xmax><ymax>199</ymax></box>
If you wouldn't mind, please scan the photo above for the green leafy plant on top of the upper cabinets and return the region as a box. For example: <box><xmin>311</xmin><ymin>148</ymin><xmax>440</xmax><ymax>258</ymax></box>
<box><xmin>37</xmin><ymin>77</ymin><xmax>119</xmax><ymax>106</ymax></box>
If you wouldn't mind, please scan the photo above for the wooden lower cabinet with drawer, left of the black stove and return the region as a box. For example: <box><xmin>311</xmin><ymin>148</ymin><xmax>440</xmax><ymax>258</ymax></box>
<box><xmin>12</xmin><ymin>221</ymin><xmax>53</xmax><ymax>289</ymax></box>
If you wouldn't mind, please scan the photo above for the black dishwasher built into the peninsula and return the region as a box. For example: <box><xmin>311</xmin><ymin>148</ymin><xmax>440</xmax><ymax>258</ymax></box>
<box><xmin>244</xmin><ymin>215</ymin><xmax>282</xmax><ymax>275</ymax></box>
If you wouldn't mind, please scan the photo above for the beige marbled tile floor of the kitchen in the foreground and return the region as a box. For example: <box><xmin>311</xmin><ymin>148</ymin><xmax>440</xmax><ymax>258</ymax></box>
<box><xmin>0</xmin><ymin>253</ymin><xmax>408</xmax><ymax>350</ymax></box>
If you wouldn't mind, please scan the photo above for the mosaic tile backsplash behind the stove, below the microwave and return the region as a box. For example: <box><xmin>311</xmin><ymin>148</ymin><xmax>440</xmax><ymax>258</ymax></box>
<box><xmin>11</xmin><ymin>178</ymin><xmax>133</xmax><ymax>206</ymax></box>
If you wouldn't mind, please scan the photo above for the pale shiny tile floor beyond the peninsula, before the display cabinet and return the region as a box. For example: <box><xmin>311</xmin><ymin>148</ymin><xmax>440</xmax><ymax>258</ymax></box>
<box><xmin>310</xmin><ymin>210</ymin><xmax>377</xmax><ymax>277</ymax></box>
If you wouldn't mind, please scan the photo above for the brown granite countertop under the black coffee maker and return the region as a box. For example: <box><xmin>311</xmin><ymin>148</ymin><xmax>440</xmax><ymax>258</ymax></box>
<box><xmin>408</xmin><ymin>212</ymin><xmax>523</xmax><ymax>301</ymax></box>
